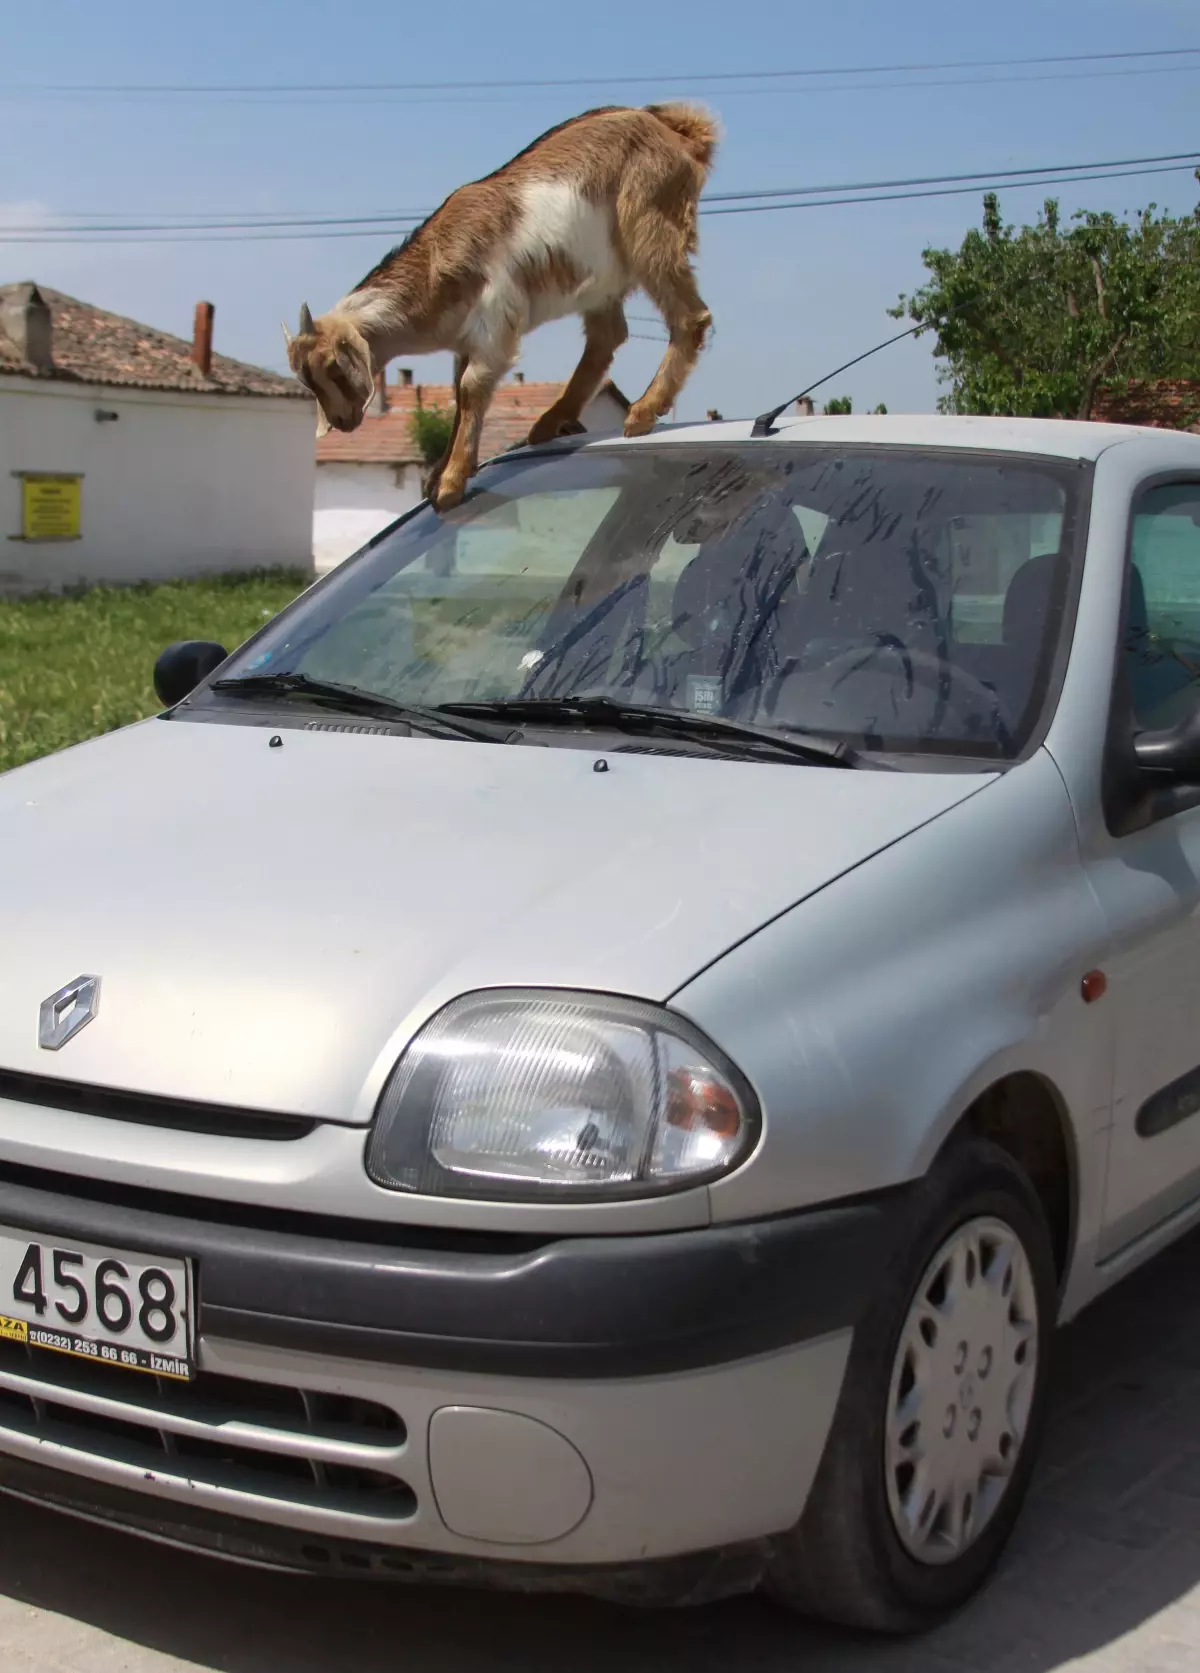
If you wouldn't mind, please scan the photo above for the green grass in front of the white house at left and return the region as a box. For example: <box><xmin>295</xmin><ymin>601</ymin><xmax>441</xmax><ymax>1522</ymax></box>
<box><xmin>0</xmin><ymin>570</ymin><xmax>310</xmax><ymax>773</ymax></box>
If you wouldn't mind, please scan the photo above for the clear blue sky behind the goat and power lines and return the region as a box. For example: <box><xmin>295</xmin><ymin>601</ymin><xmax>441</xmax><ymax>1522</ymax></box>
<box><xmin>0</xmin><ymin>0</ymin><xmax>1200</xmax><ymax>417</ymax></box>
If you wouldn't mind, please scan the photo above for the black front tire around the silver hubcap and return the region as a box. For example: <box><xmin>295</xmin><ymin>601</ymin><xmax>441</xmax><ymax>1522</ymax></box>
<box><xmin>765</xmin><ymin>1138</ymin><xmax>1058</xmax><ymax>1633</ymax></box>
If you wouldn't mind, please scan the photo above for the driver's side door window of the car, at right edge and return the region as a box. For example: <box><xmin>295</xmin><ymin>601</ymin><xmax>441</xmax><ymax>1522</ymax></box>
<box><xmin>1125</xmin><ymin>483</ymin><xmax>1200</xmax><ymax>729</ymax></box>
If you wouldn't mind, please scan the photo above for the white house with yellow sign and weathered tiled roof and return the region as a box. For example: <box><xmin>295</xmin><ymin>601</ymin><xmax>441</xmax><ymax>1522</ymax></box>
<box><xmin>0</xmin><ymin>283</ymin><xmax>315</xmax><ymax>592</ymax></box>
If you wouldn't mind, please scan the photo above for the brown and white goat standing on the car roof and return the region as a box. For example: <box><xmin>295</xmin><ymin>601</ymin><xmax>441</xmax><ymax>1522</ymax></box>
<box><xmin>285</xmin><ymin>104</ymin><xmax>718</xmax><ymax>510</ymax></box>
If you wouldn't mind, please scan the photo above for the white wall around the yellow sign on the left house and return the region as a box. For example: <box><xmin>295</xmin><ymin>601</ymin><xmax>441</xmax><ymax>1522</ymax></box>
<box><xmin>0</xmin><ymin>376</ymin><xmax>315</xmax><ymax>592</ymax></box>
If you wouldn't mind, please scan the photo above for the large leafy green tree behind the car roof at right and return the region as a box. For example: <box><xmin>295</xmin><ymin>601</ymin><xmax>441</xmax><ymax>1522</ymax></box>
<box><xmin>890</xmin><ymin>171</ymin><xmax>1200</xmax><ymax>418</ymax></box>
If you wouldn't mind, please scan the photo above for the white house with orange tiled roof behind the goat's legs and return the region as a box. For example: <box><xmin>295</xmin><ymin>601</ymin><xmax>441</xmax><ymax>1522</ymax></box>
<box><xmin>313</xmin><ymin>368</ymin><xmax>629</xmax><ymax>574</ymax></box>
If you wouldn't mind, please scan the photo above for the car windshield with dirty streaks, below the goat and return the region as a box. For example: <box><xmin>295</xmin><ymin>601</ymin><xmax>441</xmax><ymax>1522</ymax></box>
<box><xmin>214</xmin><ymin>443</ymin><xmax>1086</xmax><ymax>758</ymax></box>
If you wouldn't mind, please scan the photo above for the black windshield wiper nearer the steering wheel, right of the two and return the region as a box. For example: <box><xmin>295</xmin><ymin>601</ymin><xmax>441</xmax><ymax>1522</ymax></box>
<box><xmin>442</xmin><ymin>698</ymin><xmax>862</xmax><ymax>766</ymax></box>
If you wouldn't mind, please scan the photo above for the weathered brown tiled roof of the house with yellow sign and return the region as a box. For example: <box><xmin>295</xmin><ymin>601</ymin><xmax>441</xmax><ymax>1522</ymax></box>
<box><xmin>0</xmin><ymin>284</ymin><xmax>311</xmax><ymax>400</ymax></box>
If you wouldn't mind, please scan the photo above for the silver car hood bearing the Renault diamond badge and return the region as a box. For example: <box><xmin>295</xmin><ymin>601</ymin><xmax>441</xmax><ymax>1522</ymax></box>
<box><xmin>0</xmin><ymin>719</ymin><xmax>987</xmax><ymax>1123</ymax></box>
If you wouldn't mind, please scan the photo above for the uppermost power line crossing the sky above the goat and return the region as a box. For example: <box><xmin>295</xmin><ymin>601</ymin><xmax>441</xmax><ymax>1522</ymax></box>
<box><xmin>0</xmin><ymin>47</ymin><xmax>1200</xmax><ymax>97</ymax></box>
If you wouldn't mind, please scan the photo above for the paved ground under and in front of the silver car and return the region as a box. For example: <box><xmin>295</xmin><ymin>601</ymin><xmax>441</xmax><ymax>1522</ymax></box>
<box><xmin>0</xmin><ymin>1217</ymin><xmax>1200</xmax><ymax>1673</ymax></box>
